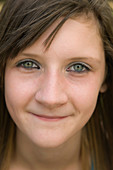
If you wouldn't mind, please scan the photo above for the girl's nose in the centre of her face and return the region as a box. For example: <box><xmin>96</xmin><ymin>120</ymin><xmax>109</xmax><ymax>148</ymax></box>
<box><xmin>35</xmin><ymin>73</ymin><xmax>68</xmax><ymax>109</ymax></box>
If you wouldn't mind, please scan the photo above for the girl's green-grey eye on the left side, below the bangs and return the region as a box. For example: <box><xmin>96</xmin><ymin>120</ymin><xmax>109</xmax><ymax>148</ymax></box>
<box><xmin>16</xmin><ymin>59</ymin><xmax>40</xmax><ymax>70</ymax></box>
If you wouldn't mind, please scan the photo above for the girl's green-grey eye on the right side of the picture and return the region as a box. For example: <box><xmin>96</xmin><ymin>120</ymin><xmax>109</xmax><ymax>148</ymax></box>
<box><xmin>67</xmin><ymin>62</ymin><xmax>90</xmax><ymax>73</ymax></box>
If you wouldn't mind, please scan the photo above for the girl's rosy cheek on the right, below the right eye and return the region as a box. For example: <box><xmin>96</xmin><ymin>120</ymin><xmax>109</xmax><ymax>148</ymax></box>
<box><xmin>69</xmin><ymin>78</ymin><xmax>100</xmax><ymax>116</ymax></box>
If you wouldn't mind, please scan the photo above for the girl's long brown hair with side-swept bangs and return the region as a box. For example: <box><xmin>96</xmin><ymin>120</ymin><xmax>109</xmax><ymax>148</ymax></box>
<box><xmin>0</xmin><ymin>0</ymin><xmax>113</xmax><ymax>170</ymax></box>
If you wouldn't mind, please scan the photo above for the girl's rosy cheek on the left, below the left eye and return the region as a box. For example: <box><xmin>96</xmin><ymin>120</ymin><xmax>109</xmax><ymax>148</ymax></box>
<box><xmin>5</xmin><ymin>72</ymin><xmax>35</xmax><ymax>114</ymax></box>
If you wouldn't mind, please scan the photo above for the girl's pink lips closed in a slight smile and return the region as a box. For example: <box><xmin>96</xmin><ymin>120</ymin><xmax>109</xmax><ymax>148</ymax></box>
<box><xmin>30</xmin><ymin>114</ymin><xmax>69</xmax><ymax>122</ymax></box>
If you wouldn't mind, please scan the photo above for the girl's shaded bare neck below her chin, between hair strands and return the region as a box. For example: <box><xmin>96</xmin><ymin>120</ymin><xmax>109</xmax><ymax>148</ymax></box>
<box><xmin>11</xmin><ymin>131</ymin><xmax>81</xmax><ymax>170</ymax></box>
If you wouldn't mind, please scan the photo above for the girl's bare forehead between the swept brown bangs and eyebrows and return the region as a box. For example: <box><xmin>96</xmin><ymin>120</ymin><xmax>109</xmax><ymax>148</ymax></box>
<box><xmin>21</xmin><ymin>16</ymin><xmax>103</xmax><ymax>59</ymax></box>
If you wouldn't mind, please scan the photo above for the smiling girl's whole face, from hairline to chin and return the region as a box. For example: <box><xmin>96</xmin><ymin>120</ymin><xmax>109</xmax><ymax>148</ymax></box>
<box><xmin>5</xmin><ymin>18</ymin><xmax>105</xmax><ymax>147</ymax></box>
